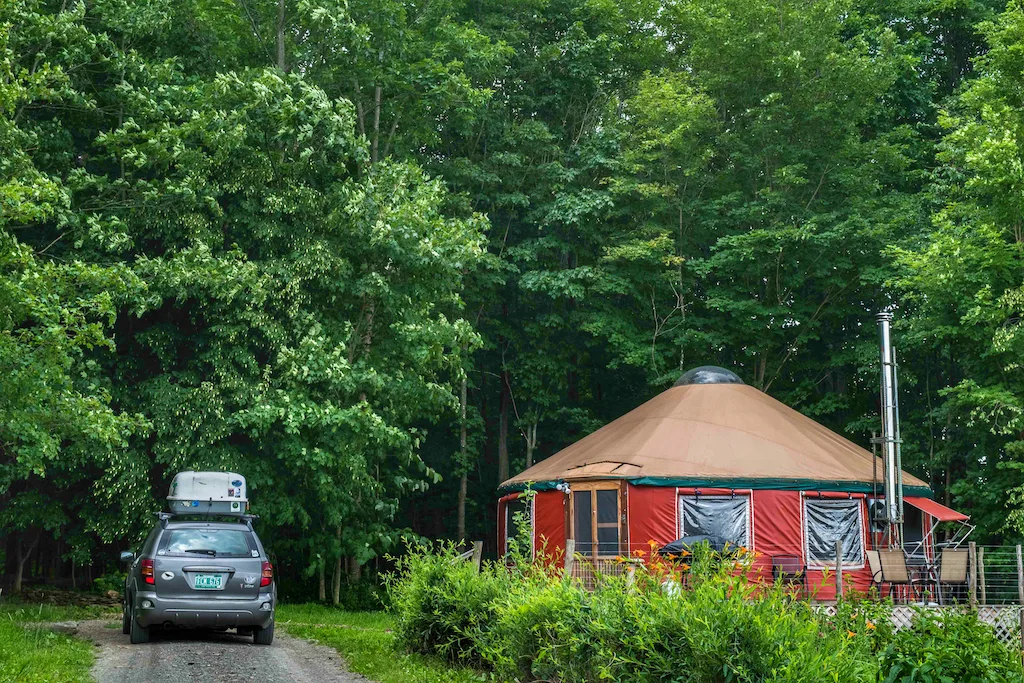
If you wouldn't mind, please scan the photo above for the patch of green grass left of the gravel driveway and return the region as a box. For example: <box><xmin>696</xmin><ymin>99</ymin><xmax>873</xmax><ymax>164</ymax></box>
<box><xmin>0</xmin><ymin>614</ymin><xmax>93</xmax><ymax>683</ymax></box>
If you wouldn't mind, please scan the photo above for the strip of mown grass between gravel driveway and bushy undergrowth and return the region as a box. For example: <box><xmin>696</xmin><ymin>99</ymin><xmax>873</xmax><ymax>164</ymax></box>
<box><xmin>276</xmin><ymin>604</ymin><xmax>483</xmax><ymax>683</ymax></box>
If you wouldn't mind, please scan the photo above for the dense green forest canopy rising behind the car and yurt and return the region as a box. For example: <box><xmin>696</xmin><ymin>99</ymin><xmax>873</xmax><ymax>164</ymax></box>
<box><xmin>0</xmin><ymin>0</ymin><xmax>1024</xmax><ymax>596</ymax></box>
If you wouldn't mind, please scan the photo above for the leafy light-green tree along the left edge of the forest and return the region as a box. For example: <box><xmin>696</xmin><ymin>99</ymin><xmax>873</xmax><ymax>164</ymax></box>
<box><xmin>0</xmin><ymin>2</ymin><xmax>144</xmax><ymax>592</ymax></box>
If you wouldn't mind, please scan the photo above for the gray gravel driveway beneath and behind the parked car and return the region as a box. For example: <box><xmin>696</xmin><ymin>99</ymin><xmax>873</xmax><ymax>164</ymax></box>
<box><xmin>78</xmin><ymin>621</ymin><xmax>370</xmax><ymax>683</ymax></box>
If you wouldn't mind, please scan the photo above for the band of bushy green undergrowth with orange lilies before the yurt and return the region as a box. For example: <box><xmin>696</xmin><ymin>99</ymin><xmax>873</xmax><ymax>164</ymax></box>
<box><xmin>388</xmin><ymin>546</ymin><xmax>1022</xmax><ymax>683</ymax></box>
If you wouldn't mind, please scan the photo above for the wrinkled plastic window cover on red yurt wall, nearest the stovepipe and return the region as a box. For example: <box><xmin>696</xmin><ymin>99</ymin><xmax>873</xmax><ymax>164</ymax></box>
<box><xmin>804</xmin><ymin>498</ymin><xmax>864</xmax><ymax>569</ymax></box>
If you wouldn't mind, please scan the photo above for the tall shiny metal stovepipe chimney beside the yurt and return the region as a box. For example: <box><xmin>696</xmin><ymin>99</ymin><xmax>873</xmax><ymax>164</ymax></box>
<box><xmin>878</xmin><ymin>312</ymin><xmax>903</xmax><ymax>546</ymax></box>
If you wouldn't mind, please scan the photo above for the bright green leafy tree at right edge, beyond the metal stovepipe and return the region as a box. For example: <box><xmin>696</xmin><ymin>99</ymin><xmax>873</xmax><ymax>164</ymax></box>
<box><xmin>895</xmin><ymin>3</ymin><xmax>1024</xmax><ymax>535</ymax></box>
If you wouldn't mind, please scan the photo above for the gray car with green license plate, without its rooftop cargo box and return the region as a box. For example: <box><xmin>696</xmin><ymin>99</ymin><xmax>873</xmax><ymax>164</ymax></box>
<box><xmin>121</xmin><ymin>513</ymin><xmax>278</xmax><ymax>645</ymax></box>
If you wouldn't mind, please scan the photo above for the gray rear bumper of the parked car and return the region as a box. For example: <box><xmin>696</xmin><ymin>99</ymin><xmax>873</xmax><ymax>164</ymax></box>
<box><xmin>132</xmin><ymin>591</ymin><xmax>275</xmax><ymax>629</ymax></box>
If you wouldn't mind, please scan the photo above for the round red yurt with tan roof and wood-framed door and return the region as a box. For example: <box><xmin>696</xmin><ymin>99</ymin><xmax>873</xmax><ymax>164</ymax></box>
<box><xmin>498</xmin><ymin>366</ymin><xmax>967</xmax><ymax>599</ymax></box>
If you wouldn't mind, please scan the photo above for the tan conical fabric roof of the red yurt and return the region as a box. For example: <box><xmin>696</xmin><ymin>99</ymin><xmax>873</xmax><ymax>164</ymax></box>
<box><xmin>502</xmin><ymin>384</ymin><xmax>928</xmax><ymax>487</ymax></box>
